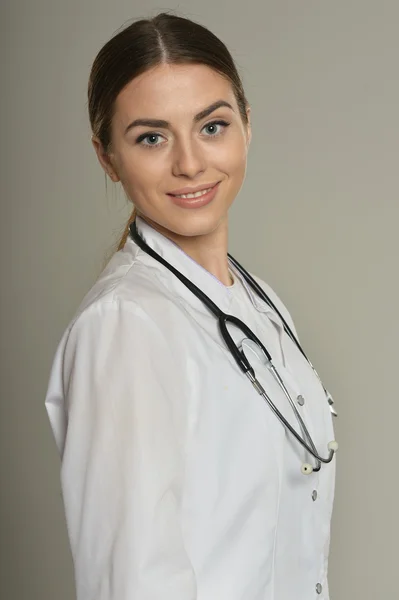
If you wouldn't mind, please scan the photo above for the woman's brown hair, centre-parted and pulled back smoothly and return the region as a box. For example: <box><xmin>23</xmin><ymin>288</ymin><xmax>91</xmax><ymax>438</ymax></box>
<box><xmin>88</xmin><ymin>13</ymin><xmax>247</xmax><ymax>250</ymax></box>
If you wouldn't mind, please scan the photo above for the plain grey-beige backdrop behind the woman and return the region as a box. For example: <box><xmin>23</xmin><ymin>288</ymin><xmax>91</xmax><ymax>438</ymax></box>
<box><xmin>0</xmin><ymin>0</ymin><xmax>399</xmax><ymax>600</ymax></box>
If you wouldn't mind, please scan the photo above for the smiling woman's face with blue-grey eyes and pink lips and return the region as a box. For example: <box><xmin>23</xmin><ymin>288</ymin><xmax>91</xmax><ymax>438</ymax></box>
<box><xmin>94</xmin><ymin>64</ymin><xmax>250</xmax><ymax>237</ymax></box>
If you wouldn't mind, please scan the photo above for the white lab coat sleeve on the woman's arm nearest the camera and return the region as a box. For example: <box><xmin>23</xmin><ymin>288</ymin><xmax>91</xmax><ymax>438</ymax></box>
<box><xmin>54</xmin><ymin>301</ymin><xmax>196</xmax><ymax>600</ymax></box>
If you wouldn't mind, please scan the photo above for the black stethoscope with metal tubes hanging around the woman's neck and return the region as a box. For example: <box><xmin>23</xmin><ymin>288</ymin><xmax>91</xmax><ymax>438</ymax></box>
<box><xmin>129</xmin><ymin>221</ymin><xmax>338</xmax><ymax>475</ymax></box>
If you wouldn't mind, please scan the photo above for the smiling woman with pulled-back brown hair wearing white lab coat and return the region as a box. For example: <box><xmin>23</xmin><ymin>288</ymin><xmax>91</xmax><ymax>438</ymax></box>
<box><xmin>46</xmin><ymin>14</ymin><xmax>335</xmax><ymax>600</ymax></box>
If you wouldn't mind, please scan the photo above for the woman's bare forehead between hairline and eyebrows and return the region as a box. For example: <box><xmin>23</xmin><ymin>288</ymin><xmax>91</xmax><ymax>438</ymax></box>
<box><xmin>115</xmin><ymin>64</ymin><xmax>236</xmax><ymax>122</ymax></box>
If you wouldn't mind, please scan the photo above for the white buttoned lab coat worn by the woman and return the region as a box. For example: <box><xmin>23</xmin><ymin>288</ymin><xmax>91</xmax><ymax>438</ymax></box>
<box><xmin>46</xmin><ymin>217</ymin><xmax>335</xmax><ymax>600</ymax></box>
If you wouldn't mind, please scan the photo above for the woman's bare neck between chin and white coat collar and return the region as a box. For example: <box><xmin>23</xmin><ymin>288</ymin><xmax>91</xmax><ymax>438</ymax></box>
<box><xmin>140</xmin><ymin>215</ymin><xmax>233</xmax><ymax>286</ymax></box>
